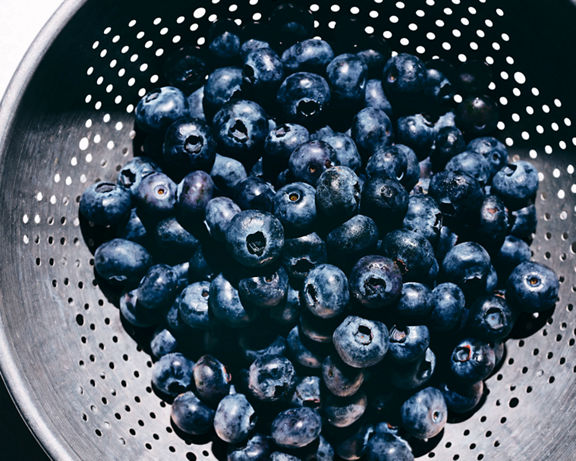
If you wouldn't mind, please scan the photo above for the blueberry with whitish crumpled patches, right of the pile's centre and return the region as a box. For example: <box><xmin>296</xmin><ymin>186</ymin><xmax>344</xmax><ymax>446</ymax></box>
<box><xmin>402</xmin><ymin>194</ymin><xmax>442</xmax><ymax>244</ymax></box>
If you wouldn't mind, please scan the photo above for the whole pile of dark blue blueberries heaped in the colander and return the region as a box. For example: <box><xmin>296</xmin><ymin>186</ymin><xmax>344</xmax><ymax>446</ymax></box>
<box><xmin>80</xmin><ymin>4</ymin><xmax>559</xmax><ymax>461</ymax></box>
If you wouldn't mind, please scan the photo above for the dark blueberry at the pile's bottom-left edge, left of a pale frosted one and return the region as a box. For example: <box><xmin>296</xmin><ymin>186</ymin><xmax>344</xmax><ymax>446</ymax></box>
<box><xmin>171</xmin><ymin>391</ymin><xmax>214</xmax><ymax>435</ymax></box>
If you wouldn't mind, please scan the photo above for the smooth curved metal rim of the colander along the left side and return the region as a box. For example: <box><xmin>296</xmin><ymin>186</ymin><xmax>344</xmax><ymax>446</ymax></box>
<box><xmin>0</xmin><ymin>0</ymin><xmax>87</xmax><ymax>461</ymax></box>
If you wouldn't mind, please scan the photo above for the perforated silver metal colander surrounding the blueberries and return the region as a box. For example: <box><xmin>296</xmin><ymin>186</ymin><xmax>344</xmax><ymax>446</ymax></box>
<box><xmin>0</xmin><ymin>0</ymin><xmax>576</xmax><ymax>461</ymax></box>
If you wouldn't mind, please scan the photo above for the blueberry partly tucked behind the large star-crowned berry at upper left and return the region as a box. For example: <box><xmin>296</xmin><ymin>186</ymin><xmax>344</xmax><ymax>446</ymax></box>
<box><xmin>203</xmin><ymin>67</ymin><xmax>244</xmax><ymax>121</ymax></box>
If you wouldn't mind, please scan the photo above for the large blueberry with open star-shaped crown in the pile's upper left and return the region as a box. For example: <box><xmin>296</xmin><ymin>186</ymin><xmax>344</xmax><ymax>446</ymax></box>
<box><xmin>213</xmin><ymin>99</ymin><xmax>268</xmax><ymax>163</ymax></box>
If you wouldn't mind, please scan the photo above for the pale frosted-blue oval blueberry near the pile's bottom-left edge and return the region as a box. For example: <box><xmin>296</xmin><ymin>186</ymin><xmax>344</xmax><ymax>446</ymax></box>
<box><xmin>214</xmin><ymin>394</ymin><xmax>256</xmax><ymax>443</ymax></box>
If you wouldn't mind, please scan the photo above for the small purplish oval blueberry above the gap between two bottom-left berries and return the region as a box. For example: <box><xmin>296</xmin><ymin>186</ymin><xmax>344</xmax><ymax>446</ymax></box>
<box><xmin>192</xmin><ymin>355</ymin><xmax>232</xmax><ymax>405</ymax></box>
